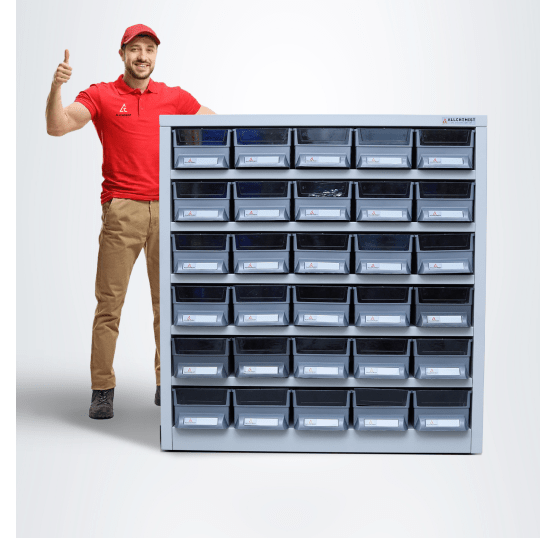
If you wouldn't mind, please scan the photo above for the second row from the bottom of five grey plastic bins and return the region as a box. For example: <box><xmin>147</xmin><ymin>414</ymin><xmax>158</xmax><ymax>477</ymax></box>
<box><xmin>172</xmin><ymin>337</ymin><xmax>472</xmax><ymax>380</ymax></box>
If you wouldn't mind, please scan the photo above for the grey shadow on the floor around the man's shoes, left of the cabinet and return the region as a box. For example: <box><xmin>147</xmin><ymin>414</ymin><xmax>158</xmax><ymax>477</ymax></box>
<box><xmin>17</xmin><ymin>384</ymin><xmax>160</xmax><ymax>452</ymax></box>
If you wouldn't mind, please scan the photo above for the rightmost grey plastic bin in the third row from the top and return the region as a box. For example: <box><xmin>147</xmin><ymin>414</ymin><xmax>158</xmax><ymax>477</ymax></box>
<box><xmin>416</xmin><ymin>233</ymin><xmax>474</xmax><ymax>275</ymax></box>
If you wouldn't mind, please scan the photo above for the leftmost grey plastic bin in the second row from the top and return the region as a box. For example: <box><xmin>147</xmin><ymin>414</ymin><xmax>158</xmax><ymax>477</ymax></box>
<box><xmin>173</xmin><ymin>181</ymin><xmax>231</xmax><ymax>221</ymax></box>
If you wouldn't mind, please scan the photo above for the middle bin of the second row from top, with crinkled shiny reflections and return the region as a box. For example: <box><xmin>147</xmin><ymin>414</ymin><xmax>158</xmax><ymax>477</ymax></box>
<box><xmin>294</xmin><ymin>181</ymin><xmax>352</xmax><ymax>221</ymax></box>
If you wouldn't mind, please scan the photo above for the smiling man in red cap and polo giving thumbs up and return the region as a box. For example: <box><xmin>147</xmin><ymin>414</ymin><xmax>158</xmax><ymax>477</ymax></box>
<box><xmin>46</xmin><ymin>25</ymin><xmax>214</xmax><ymax>419</ymax></box>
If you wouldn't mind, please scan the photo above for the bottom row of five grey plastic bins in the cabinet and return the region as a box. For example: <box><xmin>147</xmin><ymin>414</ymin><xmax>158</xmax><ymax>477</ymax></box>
<box><xmin>174</xmin><ymin>387</ymin><xmax>471</xmax><ymax>432</ymax></box>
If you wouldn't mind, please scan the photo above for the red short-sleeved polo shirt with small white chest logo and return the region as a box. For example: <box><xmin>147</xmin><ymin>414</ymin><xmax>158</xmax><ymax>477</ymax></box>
<box><xmin>75</xmin><ymin>75</ymin><xmax>201</xmax><ymax>204</ymax></box>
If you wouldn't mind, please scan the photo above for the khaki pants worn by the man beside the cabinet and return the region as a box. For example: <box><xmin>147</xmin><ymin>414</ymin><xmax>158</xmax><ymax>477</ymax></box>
<box><xmin>90</xmin><ymin>198</ymin><xmax>160</xmax><ymax>390</ymax></box>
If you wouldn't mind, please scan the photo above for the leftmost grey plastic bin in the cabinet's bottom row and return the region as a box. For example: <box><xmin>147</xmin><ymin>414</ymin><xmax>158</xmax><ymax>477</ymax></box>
<box><xmin>173</xmin><ymin>387</ymin><xmax>230</xmax><ymax>430</ymax></box>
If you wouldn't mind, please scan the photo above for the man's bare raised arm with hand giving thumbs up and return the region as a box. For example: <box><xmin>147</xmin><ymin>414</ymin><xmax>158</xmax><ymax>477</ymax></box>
<box><xmin>45</xmin><ymin>50</ymin><xmax>92</xmax><ymax>137</ymax></box>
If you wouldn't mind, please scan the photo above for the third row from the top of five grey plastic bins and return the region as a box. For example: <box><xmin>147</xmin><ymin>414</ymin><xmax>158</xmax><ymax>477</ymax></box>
<box><xmin>171</xmin><ymin>233</ymin><xmax>474</xmax><ymax>275</ymax></box>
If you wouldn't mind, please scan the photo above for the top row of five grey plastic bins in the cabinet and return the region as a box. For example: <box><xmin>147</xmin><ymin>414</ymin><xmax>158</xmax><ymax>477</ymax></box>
<box><xmin>172</xmin><ymin>127</ymin><xmax>475</xmax><ymax>169</ymax></box>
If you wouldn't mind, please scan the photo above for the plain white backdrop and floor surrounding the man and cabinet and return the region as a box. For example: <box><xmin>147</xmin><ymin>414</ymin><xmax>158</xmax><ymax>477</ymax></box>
<box><xmin>17</xmin><ymin>0</ymin><xmax>540</xmax><ymax>537</ymax></box>
